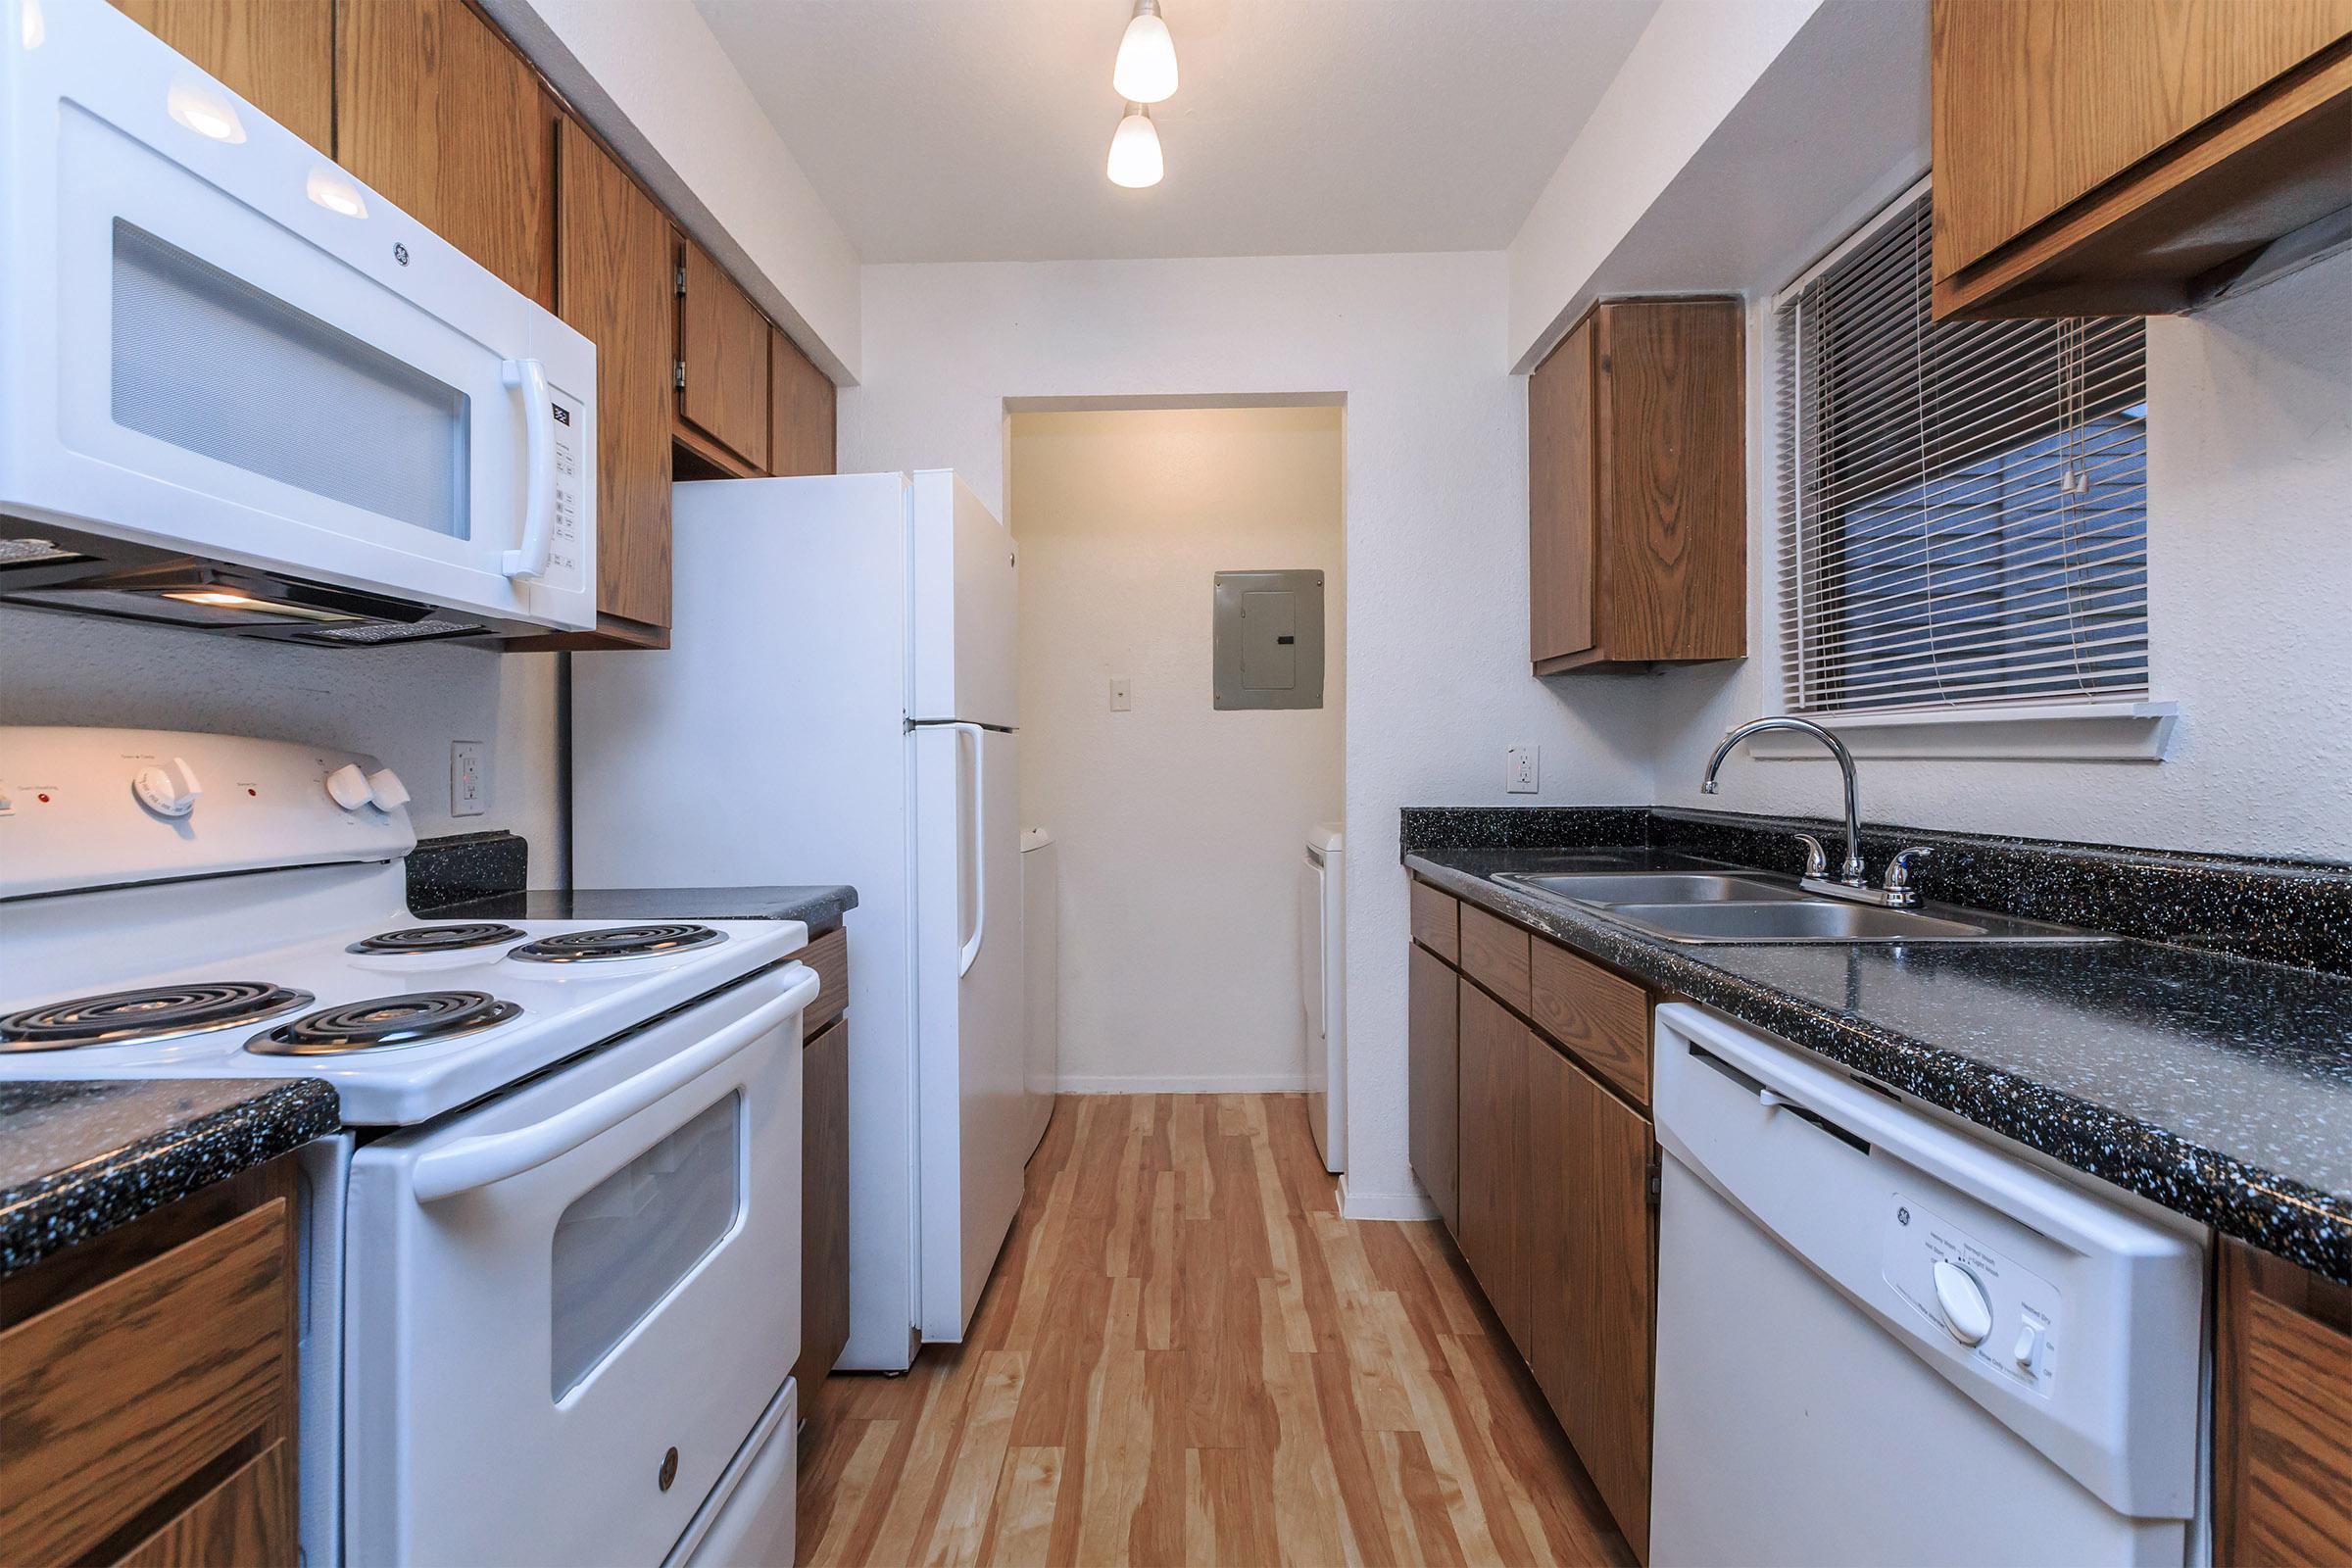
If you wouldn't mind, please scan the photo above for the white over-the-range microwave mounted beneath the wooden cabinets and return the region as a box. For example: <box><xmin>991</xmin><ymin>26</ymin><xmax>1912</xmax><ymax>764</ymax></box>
<box><xmin>0</xmin><ymin>0</ymin><xmax>595</xmax><ymax>647</ymax></box>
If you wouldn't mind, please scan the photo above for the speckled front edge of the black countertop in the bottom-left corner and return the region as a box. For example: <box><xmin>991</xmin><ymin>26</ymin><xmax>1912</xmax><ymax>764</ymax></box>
<box><xmin>0</xmin><ymin>1079</ymin><xmax>343</xmax><ymax>1279</ymax></box>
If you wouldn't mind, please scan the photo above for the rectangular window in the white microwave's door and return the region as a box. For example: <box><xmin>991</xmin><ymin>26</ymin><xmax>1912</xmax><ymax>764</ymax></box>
<box><xmin>113</xmin><ymin>219</ymin><xmax>472</xmax><ymax>538</ymax></box>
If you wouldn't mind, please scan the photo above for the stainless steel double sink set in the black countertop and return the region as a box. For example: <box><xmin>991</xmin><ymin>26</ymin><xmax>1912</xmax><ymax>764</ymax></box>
<box><xmin>1495</xmin><ymin>870</ymin><xmax>2115</xmax><ymax>945</ymax></box>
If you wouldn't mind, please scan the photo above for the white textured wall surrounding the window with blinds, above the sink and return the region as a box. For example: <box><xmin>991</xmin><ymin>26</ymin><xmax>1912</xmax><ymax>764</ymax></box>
<box><xmin>1656</xmin><ymin>256</ymin><xmax>2352</xmax><ymax>858</ymax></box>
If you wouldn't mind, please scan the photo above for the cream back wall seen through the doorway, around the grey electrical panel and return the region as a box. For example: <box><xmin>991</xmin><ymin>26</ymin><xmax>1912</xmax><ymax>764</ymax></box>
<box><xmin>1006</xmin><ymin>407</ymin><xmax>1346</xmax><ymax>1093</ymax></box>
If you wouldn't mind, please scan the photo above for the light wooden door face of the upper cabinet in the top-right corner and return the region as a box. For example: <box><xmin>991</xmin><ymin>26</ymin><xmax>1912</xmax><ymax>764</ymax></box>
<box><xmin>1931</xmin><ymin>0</ymin><xmax>2352</xmax><ymax>277</ymax></box>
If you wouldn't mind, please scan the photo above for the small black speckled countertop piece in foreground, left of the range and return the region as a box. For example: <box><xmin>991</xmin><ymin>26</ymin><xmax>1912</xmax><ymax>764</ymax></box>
<box><xmin>0</xmin><ymin>1079</ymin><xmax>343</xmax><ymax>1279</ymax></box>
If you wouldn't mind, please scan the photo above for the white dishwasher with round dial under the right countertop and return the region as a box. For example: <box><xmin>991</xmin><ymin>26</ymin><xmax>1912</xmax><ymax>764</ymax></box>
<box><xmin>1651</xmin><ymin>1004</ymin><xmax>2204</xmax><ymax>1568</ymax></box>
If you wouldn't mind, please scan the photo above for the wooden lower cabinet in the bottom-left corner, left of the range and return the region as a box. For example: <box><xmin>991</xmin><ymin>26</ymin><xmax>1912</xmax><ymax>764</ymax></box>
<box><xmin>0</xmin><ymin>1156</ymin><xmax>299</xmax><ymax>1568</ymax></box>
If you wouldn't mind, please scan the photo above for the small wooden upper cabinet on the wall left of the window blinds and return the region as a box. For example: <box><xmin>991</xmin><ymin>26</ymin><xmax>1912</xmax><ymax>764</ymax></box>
<box><xmin>1527</xmin><ymin>299</ymin><xmax>1747</xmax><ymax>674</ymax></box>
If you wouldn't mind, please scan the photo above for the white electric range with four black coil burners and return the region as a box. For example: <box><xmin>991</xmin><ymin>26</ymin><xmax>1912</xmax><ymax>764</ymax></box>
<box><xmin>0</xmin><ymin>729</ymin><xmax>816</xmax><ymax>1566</ymax></box>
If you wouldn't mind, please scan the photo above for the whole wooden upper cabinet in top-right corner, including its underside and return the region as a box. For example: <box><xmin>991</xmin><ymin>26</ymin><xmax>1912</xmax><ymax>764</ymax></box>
<box><xmin>1931</xmin><ymin>0</ymin><xmax>2352</xmax><ymax>318</ymax></box>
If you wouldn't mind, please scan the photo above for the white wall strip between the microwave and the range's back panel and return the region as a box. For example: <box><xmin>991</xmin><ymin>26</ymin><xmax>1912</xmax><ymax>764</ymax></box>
<box><xmin>0</xmin><ymin>607</ymin><xmax>563</xmax><ymax>859</ymax></box>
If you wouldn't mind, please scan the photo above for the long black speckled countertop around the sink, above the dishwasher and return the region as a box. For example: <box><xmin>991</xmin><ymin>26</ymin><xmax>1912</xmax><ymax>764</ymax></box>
<box><xmin>1404</xmin><ymin>844</ymin><xmax>2352</xmax><ymax>1284</ymax></box>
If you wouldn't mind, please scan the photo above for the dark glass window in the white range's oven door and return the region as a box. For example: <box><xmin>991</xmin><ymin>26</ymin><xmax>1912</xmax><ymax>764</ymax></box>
<box><xmin>548</xmin><ymin>1091</ymin><xmax>743</xmax><ymax>1401</ymax></box>
